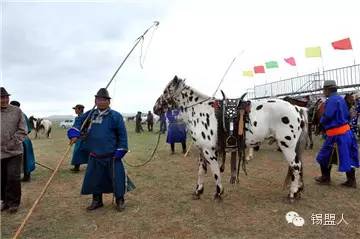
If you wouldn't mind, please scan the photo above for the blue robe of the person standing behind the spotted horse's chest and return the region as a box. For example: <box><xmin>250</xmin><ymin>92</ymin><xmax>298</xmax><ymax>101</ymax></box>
<box><xmin>166</xmin><ymin>110</ymin><xmax>186</xmax><ymax>144</ymax></box>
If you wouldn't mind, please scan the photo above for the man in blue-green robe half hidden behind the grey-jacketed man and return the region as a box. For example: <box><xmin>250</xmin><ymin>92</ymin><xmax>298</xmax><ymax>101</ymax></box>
<box><xmin>10</xmin><ymin>100</ymin><xmax>36</xmax><ymax>182</ymax></box>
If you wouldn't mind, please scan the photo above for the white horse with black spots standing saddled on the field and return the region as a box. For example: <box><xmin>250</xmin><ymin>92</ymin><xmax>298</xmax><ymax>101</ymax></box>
<box><xmin>153</xmin><ymin>76</ymin><xmax>304</xmax><ymax>202</ymax></box>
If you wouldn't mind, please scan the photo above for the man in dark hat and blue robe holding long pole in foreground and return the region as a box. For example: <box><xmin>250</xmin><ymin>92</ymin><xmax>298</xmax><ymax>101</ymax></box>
<box><xmin>68</xmin><ymin>88</ymin><xmax>128</xmax><ymax>211</ymax></box>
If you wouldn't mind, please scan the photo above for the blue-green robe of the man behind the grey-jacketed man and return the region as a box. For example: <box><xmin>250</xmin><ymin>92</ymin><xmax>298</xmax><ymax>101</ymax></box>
<box><xmin>22</xmin><ymin>114</ymin><xmax>35</xmax><ymax>174</ymax></box>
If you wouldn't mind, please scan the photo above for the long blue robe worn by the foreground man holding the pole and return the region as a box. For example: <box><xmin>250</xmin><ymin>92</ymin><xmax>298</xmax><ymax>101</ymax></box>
<box><xmin>74</xmin><ymin>108</ymin><xmax>133</xmax><ymax>198</ymax></box>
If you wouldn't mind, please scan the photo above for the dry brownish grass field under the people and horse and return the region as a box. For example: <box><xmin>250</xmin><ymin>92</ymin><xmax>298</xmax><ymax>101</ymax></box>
<box><xmin>1</xmin><ymin>124</ymin><xmax>360</xmax><ymax>239</ymax></box>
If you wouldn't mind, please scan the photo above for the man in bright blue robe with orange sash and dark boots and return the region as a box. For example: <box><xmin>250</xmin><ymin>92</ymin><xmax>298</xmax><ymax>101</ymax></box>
<box><xmin>315</xmin><ymin>80</ymin><xmax>359</xmax><ymax>188</ymax></box>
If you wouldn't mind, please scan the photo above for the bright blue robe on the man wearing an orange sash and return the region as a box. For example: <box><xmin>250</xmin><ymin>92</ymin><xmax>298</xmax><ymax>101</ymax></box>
<box><xmin>316</xmin><ymin>93</ymin><xmax>359</xmax><ymax>172</ymax></box>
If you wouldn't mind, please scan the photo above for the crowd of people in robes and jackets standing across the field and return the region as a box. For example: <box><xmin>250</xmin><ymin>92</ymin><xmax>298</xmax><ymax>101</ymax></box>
<box><xmin>1</xmin><ymin>81</ymin><xmax>360</xmax><ymax>213</ymax></box>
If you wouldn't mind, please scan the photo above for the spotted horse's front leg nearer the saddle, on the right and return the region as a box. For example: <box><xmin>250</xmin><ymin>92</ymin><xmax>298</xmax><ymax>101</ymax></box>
<box><xmin>203</xmin><ymin>149</ymin><xmax>224</xmax><ymax>200</ymax></box>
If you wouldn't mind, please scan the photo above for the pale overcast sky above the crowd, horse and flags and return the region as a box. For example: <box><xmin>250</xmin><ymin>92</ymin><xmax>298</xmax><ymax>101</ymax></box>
<box><xmin>1</xmin><ymin>0</ymin><xmax>360</xmax><ymax>117</ymax></box>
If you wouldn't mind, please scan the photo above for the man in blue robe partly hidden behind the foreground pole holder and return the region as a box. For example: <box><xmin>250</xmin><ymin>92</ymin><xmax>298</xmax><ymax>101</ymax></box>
<box><xmin>70</xmin><ymin>104</ymin><xmax>89</xmax><ymax>173</ymax></box>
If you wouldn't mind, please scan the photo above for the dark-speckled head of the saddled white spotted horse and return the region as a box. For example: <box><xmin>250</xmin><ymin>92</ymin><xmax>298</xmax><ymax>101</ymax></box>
<box><xmin>153</xmin><ymin>76</ymin><xmax>186</xmax><ymax>115</ymax></box>
